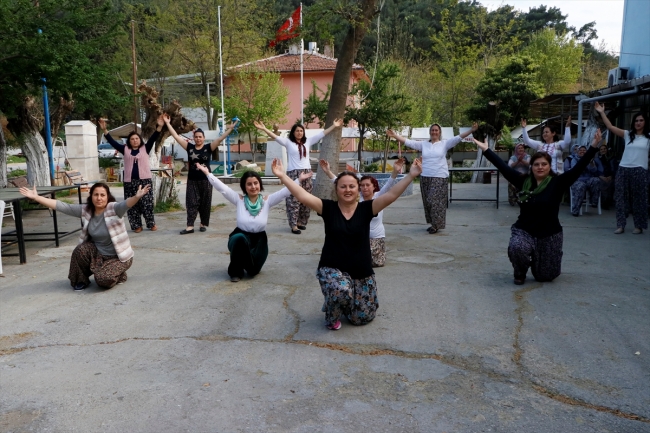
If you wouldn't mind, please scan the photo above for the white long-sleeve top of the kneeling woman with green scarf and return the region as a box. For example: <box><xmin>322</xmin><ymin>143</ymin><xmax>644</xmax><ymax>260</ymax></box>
<box><xmin>208</xmin><ymin>174</ymin><xmax>298</xmax><ymax>233</ymax></box>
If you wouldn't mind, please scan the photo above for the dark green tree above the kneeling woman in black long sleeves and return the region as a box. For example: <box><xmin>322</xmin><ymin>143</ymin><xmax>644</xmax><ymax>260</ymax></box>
<box><xmin>467</xmin><ymin>56</ymin><xmax>544</xmax><ymax>128</ymax></box>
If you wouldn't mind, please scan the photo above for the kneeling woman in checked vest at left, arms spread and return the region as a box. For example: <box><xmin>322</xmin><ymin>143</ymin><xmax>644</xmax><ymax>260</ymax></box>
<box><xmin>20</xmin><ymin>182</ymin><xmax>150</xmax><ymax>291</ymax></box>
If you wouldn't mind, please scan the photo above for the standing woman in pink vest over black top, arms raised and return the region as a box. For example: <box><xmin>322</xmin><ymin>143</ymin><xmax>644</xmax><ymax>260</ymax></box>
<box><xmin>97</xmin><ymin>116</ymin><xmax>165</xmax><ymax>233</ymax></box>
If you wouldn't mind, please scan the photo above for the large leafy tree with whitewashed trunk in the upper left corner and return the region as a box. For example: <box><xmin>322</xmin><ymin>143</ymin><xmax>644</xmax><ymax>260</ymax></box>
<box><xmin>0</xmin><ymin>0</ymin><xmax>124</xmax><ymax>185</ymax></box>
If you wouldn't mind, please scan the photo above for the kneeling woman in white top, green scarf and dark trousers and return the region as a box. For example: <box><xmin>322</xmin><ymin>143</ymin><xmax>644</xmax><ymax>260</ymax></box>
<box><xmin>196</xmin><ymin>163</ymin><xmax>311</xmax><ymax>283</ymax></box>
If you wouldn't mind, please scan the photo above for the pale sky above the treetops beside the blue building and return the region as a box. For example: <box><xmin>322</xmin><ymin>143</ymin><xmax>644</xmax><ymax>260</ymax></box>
<box><xmin>479</xmin><ymin>0</ymin><xmax>624</xmax><ymax>54</ymax></box>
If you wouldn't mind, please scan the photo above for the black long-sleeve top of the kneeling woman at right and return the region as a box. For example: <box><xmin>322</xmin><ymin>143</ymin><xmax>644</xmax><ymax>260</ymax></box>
<box><xmin>484</xmin><ymin>146</ymin><xmax>598</xmax><ymax>238</ymax></box>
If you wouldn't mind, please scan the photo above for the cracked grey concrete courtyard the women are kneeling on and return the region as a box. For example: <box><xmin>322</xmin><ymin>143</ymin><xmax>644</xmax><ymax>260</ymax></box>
<box><xmin>0</xmin><ymin>177</ymin><xmax>650</xmax><ymax>432</ymax></box>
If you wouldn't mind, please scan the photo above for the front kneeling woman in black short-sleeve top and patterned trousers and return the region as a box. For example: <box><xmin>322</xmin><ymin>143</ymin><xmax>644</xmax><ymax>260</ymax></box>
<box><xmin>273</xmin><ymin>158</ymin><xmax>422</xmax><ymax>330</ymax></box>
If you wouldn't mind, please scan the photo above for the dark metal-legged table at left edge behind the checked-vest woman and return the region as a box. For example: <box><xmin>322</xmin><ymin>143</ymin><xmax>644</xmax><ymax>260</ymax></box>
<box><xmin>0</xmin><ymin>185</ymin><xmax>81</xmax><ymax>265</ymax></box>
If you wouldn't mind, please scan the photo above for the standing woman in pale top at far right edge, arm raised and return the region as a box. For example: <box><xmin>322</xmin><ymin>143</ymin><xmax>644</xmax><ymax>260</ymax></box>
<box><xmin>594</xmin><ymin>102</ymin><xmax>650</xmax><ymax>235</ymax></box>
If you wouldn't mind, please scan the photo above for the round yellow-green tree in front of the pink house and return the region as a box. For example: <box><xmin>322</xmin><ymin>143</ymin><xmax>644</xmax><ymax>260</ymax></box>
<box><xmin>225</xmin><ymin>69</ymin><xmax>289</xmax><ymax>162</ymax></box>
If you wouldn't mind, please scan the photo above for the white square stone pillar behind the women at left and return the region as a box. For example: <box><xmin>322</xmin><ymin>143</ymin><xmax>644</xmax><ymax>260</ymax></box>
<box><xmin>65</xmin><ymin>120</ymin><xmax>100</xmax><ymax>180</ymax></box>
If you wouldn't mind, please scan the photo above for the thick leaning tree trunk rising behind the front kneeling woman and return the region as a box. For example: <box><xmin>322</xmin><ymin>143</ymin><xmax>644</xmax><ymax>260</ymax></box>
<box><xmin>313</xmin><ymin>0</ymin><xmax>377</xmax><ymax>198</ymax></box>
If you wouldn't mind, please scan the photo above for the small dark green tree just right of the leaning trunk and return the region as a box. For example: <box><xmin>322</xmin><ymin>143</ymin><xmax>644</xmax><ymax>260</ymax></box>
<box><xmin>345</xmin><ymin>63</ymin><xmax>411</xmax><ymax>165</ymax></box>
